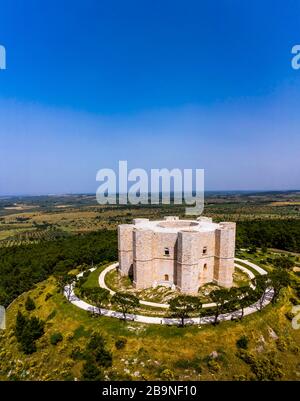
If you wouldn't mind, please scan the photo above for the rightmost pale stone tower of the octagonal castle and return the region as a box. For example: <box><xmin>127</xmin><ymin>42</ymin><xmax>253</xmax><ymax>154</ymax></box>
<box><xmin>214</xmin><ymin>222</ymin><xmax>236</xmax><ymax>288</ymax></box>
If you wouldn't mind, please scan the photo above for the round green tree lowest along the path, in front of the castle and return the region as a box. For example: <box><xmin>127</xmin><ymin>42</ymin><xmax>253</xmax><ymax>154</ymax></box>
<box><xmin>169</xmin><ymin>295</ymin><xmax>202</xmax><ymax>327</ymax></box>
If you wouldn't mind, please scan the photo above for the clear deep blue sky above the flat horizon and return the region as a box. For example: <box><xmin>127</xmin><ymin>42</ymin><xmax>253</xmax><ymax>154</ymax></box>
<box><xmin>0</xmin><ymin>0</ymin><xmax>300</xmax><ymax>195</ymax></box>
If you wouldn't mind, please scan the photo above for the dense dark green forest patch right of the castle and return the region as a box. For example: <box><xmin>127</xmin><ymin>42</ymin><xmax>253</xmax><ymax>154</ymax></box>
<box><xmin>236</xmin><ymin>220</ymin><xmax>300</xmax><ymax>252</ymax></box>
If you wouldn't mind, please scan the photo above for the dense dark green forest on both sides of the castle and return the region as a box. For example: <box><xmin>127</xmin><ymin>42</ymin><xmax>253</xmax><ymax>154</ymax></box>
<box><xmin>0</xmin><ymin>220</ymin><xmax>300</xmax><ymax>306</ymax></box>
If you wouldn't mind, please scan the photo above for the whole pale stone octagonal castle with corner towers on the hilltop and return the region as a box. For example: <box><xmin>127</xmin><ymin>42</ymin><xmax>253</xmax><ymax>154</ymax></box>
<box><xmin>118</xmin><ymin>216</ymin><xmax>236</xmax><ymax>295</ymax></box>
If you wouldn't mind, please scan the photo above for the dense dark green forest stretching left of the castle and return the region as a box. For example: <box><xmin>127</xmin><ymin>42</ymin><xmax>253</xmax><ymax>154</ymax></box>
<box><xmin>0</xmin><ymin>230</ymin><xmax>117</xmax><ymax>306</ymax></box>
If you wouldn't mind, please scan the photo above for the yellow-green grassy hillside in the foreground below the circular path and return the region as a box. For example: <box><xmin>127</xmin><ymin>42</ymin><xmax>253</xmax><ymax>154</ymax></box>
<box><xmin>0</xmin><ymin>270</ymin><xmax>300</xmax><ymax>380</ymax></box>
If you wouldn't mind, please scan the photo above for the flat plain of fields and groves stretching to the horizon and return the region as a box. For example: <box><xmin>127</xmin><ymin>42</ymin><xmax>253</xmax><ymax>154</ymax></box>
<box><xmin>0</xmin><ymin>191</ymin><xmax>300</xmax><ymax>246</ymax></box>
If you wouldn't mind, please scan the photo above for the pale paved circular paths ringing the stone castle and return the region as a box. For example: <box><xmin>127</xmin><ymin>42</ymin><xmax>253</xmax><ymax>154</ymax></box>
<box><xmin>64</xmin><ymin>258</ymin><xmax>274</xmax><ymax>325</ymax></box>
